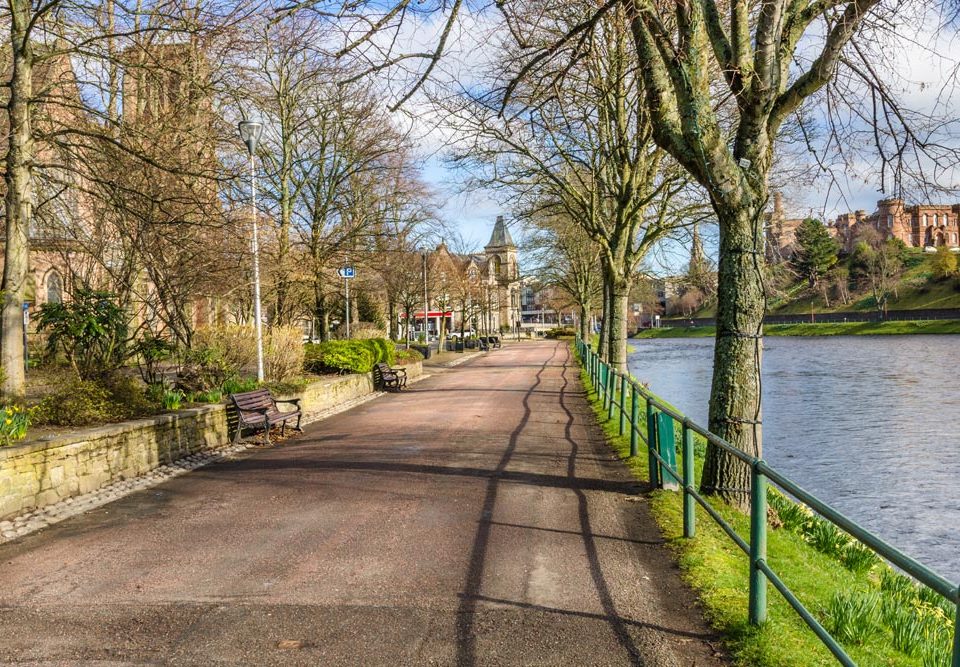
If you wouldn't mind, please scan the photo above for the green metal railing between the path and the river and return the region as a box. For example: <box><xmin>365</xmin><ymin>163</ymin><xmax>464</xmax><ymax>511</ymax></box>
<box><xmin>576</xmin><ymin>337</ymin><xmax>960</xmax><ymax>667</ymax></box>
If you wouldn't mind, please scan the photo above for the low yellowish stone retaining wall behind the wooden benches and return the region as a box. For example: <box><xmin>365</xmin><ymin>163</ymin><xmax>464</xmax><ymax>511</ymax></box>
<box><xmin>0</xmin><ymin>363</ymin><xmax>422</xmax><ymax>520</ymax></box>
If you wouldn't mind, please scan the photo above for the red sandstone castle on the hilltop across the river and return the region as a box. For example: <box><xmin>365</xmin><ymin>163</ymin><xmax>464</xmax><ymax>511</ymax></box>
<box><xmin>829</xmin><ymin>198</ymin><xmax>960</xmax><ymax>251</ymax></box>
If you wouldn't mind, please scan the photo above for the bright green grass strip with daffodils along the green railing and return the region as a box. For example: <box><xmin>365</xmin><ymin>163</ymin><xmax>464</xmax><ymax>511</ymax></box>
<box><xmin>581</xmin><ymin>362</ymin><xmax>953</xmax><ymax>667</ymax></box>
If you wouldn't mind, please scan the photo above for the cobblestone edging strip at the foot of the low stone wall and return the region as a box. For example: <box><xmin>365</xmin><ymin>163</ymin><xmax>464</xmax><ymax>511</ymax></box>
<box><xmin>0</xmin><ymin>374</ymin><xmax>430</xmax><ymax>544</ymax></box>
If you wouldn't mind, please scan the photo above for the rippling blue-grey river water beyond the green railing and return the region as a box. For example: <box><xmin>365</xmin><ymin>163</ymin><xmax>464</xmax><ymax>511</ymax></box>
<box><xmin>628</xmin><ymin>335</ymin><xmax>960</xmax><ymax>581</ymax></box>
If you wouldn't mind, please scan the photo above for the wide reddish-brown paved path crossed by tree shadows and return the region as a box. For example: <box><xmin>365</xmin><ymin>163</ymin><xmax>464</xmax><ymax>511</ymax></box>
<box><xmin>0</xmin><ymin>342</ymin><xmax>718</xmax><ymax>666</ymax></box>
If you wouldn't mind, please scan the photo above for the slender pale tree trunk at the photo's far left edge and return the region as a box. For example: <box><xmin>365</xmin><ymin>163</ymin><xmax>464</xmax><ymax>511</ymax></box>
<box><xmin>0</xmin><ymin>13</ymin><xmax>33</xmax><ymax>400</ymax></box>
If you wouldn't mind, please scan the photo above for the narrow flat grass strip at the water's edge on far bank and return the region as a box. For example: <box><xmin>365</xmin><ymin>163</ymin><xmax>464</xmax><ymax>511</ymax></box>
<box><xmin>634</xmin><ymin>320</ymin><xmax>960</xmax><ymax>338</ymax></box>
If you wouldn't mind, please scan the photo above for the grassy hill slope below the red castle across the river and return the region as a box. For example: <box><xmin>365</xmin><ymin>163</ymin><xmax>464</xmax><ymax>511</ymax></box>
<box><xmin>694</xmin><ymin>248</ymin><xmax>960</xmax><ymax>317</ymax></box>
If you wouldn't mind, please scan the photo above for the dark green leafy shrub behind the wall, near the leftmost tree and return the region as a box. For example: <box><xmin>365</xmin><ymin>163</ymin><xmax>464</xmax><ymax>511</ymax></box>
<box><xmin>37</xmin><ymin>289</ymin><xmax>127</xmax><ymax>380</ymax></box>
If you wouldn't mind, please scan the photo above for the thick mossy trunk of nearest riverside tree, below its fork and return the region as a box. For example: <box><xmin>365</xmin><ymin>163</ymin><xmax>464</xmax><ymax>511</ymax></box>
<box><xmin>701</xmin><ymin>204</ymin><xmax>764</xmax><ymax>509</ymax></box>
